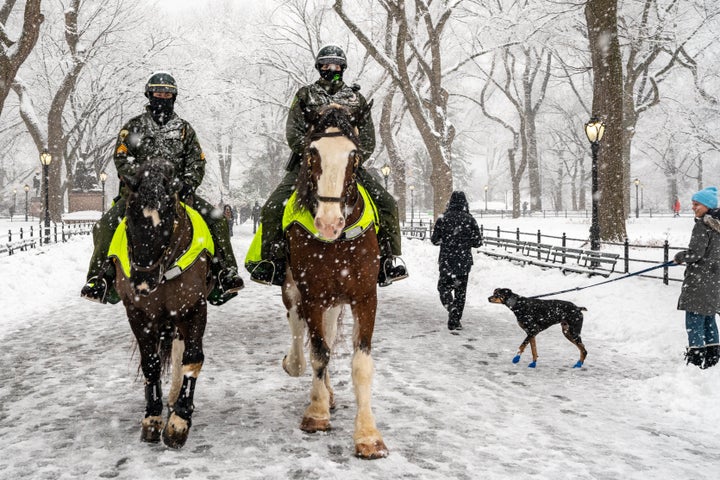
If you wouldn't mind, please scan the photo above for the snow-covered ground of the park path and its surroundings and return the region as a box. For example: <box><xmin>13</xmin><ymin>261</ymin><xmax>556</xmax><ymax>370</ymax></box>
<box><xmin>0</xmin><ymin>216</ymin><xmax>720</xmax><ymax>480</ymax></box>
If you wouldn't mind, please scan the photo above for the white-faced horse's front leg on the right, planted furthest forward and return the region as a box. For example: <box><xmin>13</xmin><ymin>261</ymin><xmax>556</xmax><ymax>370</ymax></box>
<box><xmin>352</xmin><ymin>296</ymin><xmax>388</xmax><ymax>459</ymax></box>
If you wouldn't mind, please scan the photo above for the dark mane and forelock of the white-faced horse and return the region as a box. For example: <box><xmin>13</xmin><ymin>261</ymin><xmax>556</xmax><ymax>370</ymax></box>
<box><xmin>295</xmin><ymin>103</ymin><xmax>359</xmax><ymax>210</ymax></box>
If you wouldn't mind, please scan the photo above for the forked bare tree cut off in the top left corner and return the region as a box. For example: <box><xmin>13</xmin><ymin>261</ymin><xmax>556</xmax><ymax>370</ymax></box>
<box><xmin>0</xmin><ymin>0</ymin><xmax>45</xmax><ymax>113</ymax></box>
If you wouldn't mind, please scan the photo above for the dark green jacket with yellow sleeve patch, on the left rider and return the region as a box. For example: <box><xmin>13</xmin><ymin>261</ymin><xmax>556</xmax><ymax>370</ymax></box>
<box><xmin>115</xmin><ymin>109</ymin><xmax>205</xmax><ymax>193</ymax></box>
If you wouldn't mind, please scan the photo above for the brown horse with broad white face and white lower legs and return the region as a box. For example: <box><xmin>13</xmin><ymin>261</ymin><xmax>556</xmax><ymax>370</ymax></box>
<box><xmin>282</xmin><ymin>105</ymin><xmax>388</xmax><ymax>459</ymax></box>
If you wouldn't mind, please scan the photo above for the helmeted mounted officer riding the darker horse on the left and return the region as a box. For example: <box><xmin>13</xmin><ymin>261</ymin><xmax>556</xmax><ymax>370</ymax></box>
<box><xmin>80</xmin><ymin>72</ymin><xmax>243</xmax><ymax>304</ymax></box>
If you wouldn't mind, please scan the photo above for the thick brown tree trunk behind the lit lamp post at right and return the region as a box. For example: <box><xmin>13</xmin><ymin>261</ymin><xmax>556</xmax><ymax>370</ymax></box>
<box><xmin>585</xmin><ymin>0</ymin><xmax>627</xmax><ymax>242</ymax></box>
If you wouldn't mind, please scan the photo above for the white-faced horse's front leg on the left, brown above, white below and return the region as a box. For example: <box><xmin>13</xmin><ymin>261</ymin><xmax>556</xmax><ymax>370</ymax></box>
<box><xmin>300</xmin><ymin>301</ymin><xmax>331</xmax><ymax>432</ymax></box>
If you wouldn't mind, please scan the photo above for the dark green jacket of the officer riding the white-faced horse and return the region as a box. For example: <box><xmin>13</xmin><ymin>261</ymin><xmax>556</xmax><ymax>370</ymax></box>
<box><xmin>285</xmin><ymin>78</ymin><xmax>375</xmax><ymax>168</ymax></box>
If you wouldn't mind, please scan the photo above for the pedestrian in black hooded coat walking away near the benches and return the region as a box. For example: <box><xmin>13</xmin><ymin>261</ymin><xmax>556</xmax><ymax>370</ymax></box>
<box><xmin>431</xmin><ymin>192</ymin><xmax>481</xmax><ymax>330</ymax></box>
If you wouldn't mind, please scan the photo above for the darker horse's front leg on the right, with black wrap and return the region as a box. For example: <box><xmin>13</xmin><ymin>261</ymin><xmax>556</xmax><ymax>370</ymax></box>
<box><xmin>163</xmin><ymin>300</ymin><xmax>207</xmax><ymax>448</ymax></box>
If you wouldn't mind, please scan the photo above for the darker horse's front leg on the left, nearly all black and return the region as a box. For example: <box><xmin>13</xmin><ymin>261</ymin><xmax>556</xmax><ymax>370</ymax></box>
<box><xmin>128</xmin><ymin>308</ymin><xmax>165</xmax><ymax>443</ymax></box>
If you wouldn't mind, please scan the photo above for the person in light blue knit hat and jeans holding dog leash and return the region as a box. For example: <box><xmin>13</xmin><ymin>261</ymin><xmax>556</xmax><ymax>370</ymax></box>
<box><xmin>673</xmin><ymin>187</ymin><xmax>720</xmax><ymax>369</ymax></box>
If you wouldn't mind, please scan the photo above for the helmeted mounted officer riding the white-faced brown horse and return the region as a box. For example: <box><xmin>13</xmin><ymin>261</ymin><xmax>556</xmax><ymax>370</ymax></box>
<box><xmin>246</xmin><ymin>45</ymin><xmax>407</xmax><ymax>286</ymax></box>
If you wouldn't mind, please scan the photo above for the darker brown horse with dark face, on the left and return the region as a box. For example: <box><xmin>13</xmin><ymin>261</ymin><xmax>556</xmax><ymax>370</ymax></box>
<box><xmin>111</xmin><ymin>160</ymin><xmax>212</xmax><ymax>448</ymax></box>
